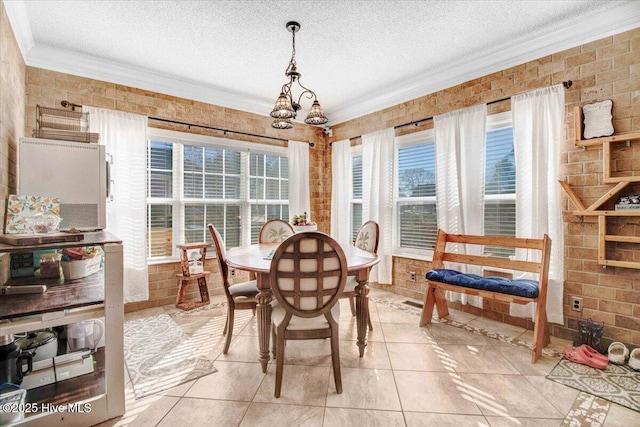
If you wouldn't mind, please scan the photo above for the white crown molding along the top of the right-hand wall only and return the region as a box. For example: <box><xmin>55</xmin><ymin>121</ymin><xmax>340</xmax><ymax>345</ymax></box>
<box><xmin>327</xmin><ymin>1</ymin><xmax>640</xmax><ymax>126</ymax></box>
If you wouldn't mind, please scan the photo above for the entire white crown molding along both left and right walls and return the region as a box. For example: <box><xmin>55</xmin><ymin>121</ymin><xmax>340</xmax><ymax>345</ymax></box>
<box><xmin>4</xmin><ymin>0</ymin><xmax>640</xmax><ymax>126</ymax></box>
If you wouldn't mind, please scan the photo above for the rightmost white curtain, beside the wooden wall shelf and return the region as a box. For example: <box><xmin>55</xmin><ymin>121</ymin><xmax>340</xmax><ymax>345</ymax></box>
<box><xmin>510</xmin><ymin>84</ymin><xmax>564</xmax><ymax>324</ymax></box>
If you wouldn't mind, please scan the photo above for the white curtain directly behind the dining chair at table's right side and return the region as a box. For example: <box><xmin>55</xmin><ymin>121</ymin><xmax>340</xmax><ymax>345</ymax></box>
<box><xmin>362</xmin><ymin>128</ymin><xmax>395</xmax><ymax>284</ymax></box>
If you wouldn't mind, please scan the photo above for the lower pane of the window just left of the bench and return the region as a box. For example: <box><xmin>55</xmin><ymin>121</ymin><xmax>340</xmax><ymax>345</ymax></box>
<box><xmin>398</xmin><ymin>203</ymin><xmax>438</xmax><ymax>250</ymax></box>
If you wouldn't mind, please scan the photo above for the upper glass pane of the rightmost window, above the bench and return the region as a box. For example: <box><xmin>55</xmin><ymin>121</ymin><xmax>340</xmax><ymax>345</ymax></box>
<box><xmin>485</xmin><ymin>127</ymin><xmax>516</xmax><ymax>194</ymax></box>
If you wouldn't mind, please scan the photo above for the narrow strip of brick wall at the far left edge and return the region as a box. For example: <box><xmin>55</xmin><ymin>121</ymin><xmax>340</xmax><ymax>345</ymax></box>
<box><xmin>0</xmin><ymin>2</ymin><xmax>25</xmax><ymax>283</ymax></box>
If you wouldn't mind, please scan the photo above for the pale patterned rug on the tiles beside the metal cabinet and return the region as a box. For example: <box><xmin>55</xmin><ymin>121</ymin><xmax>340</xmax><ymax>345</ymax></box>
<box><xmin>124</xmin><ymin>314</ymin><xmax>217</xmax><ymax>399</ymax></box>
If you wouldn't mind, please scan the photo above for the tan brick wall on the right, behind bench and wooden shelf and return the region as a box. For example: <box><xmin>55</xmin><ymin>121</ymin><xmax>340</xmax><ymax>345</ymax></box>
<box><xmin>325</xmin><ymin>29</ymin><xmax>640</xmax><ymax>345</ymax></box>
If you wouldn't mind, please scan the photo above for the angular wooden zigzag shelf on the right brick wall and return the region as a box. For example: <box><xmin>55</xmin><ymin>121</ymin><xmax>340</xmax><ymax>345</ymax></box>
<box><xmin>559</xmin><ymin>106</ymin><xmax>640</xmax><ymax>269</ymax></box>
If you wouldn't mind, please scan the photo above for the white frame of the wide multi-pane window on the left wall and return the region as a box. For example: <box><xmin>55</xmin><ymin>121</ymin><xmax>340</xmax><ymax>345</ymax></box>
<box><xmin>145</xmin><ymin>128</ymin><xmax>289</xmax><ymax>264</ymax></box>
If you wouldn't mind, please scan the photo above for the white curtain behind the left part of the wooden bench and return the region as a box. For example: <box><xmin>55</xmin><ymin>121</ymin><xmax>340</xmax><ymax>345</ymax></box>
<box><xmin>433</xmin><ymin>104</ymin><xmax>487</xmax><ymax>307</ymax></box>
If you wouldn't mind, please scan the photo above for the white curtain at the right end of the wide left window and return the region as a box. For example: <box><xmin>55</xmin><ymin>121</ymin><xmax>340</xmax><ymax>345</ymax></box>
<box><xmin>288</xmin><ymin>141</ymin><xmax>311</xmax><ymax>221</ymax></box>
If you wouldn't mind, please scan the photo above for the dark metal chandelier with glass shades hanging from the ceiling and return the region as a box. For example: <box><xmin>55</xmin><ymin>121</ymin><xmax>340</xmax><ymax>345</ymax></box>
<box><xmin>270</xmin><ymin>21</ymin><xmax>329</xmax><ymax>129</ymax></box>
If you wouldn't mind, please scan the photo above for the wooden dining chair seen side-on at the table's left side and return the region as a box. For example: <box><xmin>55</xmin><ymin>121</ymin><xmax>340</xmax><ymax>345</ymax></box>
<box><xmin>209</xmin><ymin>224</ymin><xmax>258</xmax><ymax>354</ymax></box>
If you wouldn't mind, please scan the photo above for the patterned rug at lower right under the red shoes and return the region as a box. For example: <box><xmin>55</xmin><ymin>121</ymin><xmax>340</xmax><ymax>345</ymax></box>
<box><xmin>547</xmin><ymin>359</ymin><xmax>640</xmax><ymax>412</ymax></box>
